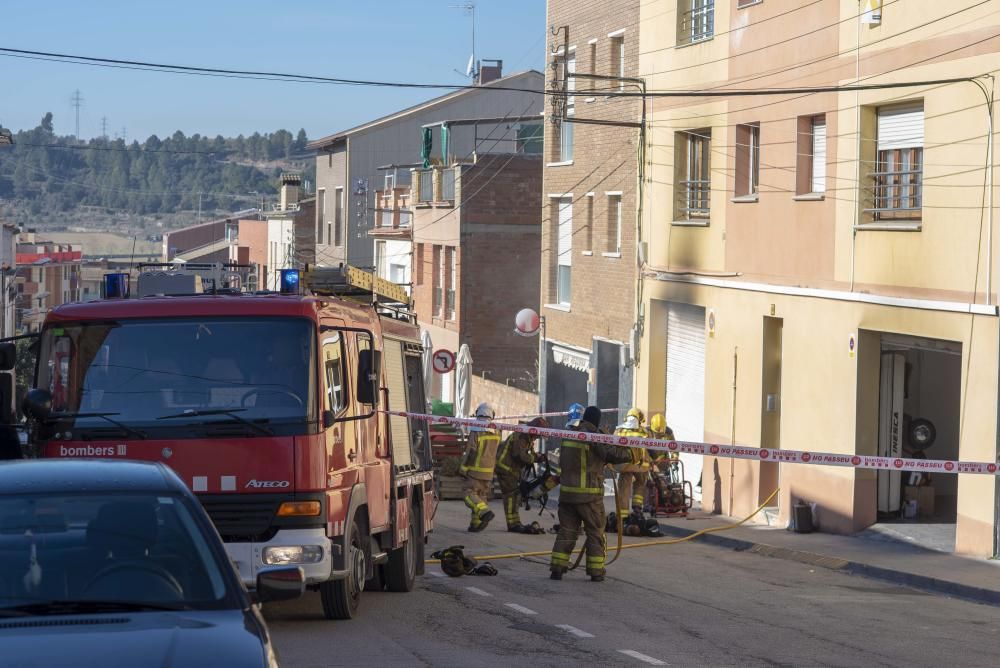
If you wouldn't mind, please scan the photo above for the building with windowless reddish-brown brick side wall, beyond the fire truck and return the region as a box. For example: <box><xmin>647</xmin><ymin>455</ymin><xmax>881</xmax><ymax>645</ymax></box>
<box><xmin>410</xmin><ymin>153</ymin><xmax>542</xmax><ymax>405</ymax></box>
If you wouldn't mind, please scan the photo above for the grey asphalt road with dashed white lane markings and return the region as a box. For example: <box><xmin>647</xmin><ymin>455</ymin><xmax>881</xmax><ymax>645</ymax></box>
<box><xmin>265</xmin><ymin>502</ymin><xmax>1000</xmax><ymax>668</ymax></box>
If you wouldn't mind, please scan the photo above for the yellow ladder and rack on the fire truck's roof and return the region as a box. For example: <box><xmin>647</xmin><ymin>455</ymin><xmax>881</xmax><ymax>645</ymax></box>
<box><xmin>302</xmin><ymin>265</ymin><xmax>417</xmax><ymax>324</ymax></box>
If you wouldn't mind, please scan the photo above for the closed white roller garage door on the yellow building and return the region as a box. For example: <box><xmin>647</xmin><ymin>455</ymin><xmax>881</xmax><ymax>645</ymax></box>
<box><xmin>666</xmin><ymin>302</ymin><xmax>705</xmax><ymax>499</ymax></box>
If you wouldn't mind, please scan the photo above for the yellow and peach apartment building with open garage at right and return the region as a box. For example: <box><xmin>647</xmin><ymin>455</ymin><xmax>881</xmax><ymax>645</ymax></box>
<box><xmin>636</xmin><ymin>0</ymin><xmax>1000</xmax><ymax>555</ymax></box>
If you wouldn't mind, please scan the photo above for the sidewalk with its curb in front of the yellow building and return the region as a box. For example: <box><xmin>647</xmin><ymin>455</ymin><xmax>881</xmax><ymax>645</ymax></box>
<box><xmin>659</xmin><ymin>512</ymin><xmax>1000</xmax><ymax>606</ymax></box>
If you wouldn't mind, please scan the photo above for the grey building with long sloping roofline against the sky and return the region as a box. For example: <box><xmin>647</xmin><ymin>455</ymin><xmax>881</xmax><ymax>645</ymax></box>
<box><xmin>308</xmin><ymin>61</ymin><xmax>543</xmax><ymax>268</ymax></box>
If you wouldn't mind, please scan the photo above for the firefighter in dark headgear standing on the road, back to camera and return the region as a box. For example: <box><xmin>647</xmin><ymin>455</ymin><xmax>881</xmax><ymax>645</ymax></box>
<box><xmin>549</xmin><ymin>406</ymin><xmax>633</xmax><ymax>582</ymax></box>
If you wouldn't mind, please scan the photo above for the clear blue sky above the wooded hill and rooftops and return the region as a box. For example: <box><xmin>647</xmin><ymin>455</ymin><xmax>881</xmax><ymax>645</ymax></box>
<box><xmin>0</xmin><ymin>0</ymin><xmax>546</xmax><ymax>140</ymax></box>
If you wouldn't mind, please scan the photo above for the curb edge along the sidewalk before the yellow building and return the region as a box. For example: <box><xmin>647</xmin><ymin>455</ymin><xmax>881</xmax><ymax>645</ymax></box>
<box><xmin>660</xmin><ymin>524</ymin><xmax>1000</xmax><ymax>607</ymax></box>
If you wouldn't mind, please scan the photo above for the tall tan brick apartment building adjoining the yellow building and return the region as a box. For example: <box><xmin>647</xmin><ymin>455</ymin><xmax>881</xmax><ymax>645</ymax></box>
<box><xmin>541</xmin><ymin>0</ymin><xmax>641</xmax><ymax>420</ymax></box>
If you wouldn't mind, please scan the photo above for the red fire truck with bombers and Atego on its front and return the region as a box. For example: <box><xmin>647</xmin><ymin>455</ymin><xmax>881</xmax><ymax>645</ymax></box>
<box><xmin>12</xmin><ymin>268</ymin><xmax>436</xmax><ymax>619</ymax></box>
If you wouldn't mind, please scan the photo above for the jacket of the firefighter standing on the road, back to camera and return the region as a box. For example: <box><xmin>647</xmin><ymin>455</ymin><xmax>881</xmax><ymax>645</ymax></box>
<box><xmin>559</xmin><ymin>422</ymin><xmax>638</xmax><ymax>503</ymax></box>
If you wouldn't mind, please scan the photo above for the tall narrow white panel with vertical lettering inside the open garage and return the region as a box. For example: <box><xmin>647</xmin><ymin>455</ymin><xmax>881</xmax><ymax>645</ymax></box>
<box><xmin>878</xmin><ymin>353</ymin><xmax>906</xmax><ymax>513</ymax></box>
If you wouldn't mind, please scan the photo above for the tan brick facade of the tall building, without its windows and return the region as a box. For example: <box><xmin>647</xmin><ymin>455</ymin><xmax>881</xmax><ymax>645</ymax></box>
<box><xmin>541</xmin><ymin>0</ymin><xmax>641</xmax><ymax>409</ymax></box>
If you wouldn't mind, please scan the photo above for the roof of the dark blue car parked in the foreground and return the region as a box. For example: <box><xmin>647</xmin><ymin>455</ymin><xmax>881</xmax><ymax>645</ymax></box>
<box><xmin>0</xmin><ymin>459</ymin><xmax>187</xmax><ymax>496</ymax></box>
